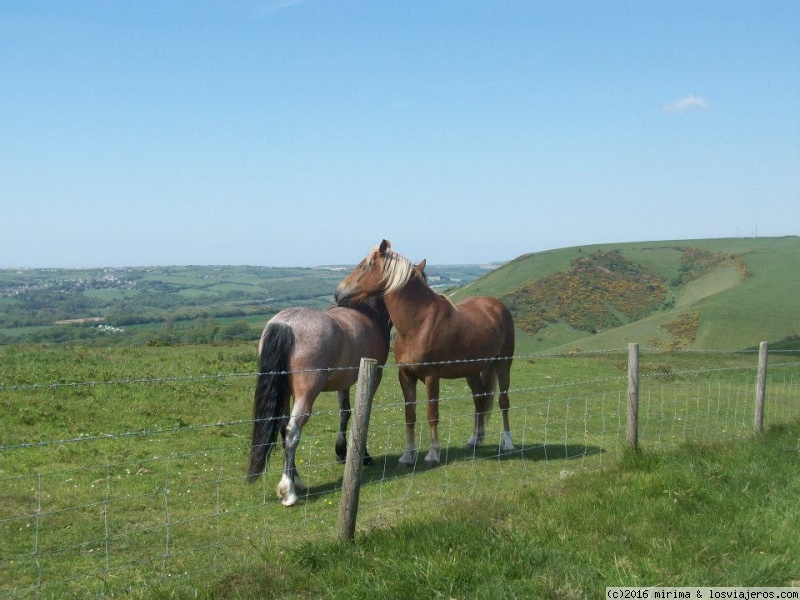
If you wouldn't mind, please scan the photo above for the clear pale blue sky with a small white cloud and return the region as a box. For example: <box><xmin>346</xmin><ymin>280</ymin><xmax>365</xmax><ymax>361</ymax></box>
<box><xmin>0</xmin><ymin>0</ymin><xmax>800</xmax><ymax>268</ymax></box>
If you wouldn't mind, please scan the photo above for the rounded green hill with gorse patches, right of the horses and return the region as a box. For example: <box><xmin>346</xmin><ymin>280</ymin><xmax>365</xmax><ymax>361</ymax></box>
<box><xmin>454</xmin><ymin>236</ymin><xmax>800</xmax><ymax>352</ymax></box>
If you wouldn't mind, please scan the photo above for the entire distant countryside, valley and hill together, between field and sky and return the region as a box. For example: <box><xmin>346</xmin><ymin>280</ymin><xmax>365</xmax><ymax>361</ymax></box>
<box><xmin>0</xmin><ymin>236</ymin><xmax>800</xmax><ymax>353</ymax></box>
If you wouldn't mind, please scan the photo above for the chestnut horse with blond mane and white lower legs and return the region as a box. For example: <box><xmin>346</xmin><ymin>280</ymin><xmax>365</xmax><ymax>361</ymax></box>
<box><xmin>334</xmin><ymin>240</ymin><xmax>514</xmax><ymax>466</ymax></box>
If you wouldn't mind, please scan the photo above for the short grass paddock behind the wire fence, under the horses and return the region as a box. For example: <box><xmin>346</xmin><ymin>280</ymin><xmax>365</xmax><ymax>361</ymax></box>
<box><xmin>0</xmin><ymin>351</ymin><xmax>800</xmax><ymax>598</ymax></box>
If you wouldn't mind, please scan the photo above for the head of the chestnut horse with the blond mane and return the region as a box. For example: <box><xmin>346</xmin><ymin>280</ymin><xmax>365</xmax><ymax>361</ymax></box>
<box><xmin>333</xmin><ymin>240</ymin><xmax>425</xmax><ymax>306</ymax></box>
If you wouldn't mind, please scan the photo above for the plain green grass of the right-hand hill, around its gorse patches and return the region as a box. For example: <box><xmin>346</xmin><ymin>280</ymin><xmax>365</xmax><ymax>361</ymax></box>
<box><xmin>454</xmin><ymin>237</ymin><xmax>800</xmax><ymax>352</ymax></box>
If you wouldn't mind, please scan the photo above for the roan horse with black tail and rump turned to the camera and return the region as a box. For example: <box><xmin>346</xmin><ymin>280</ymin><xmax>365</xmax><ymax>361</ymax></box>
<box><xmin>248</xmin><ymin>299</ymin><xmax>391</xmax><ymax>506</ymax></box>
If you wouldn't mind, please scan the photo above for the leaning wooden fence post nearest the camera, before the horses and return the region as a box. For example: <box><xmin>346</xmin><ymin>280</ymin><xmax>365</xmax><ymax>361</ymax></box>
<box><xmin>339</xmin><ymin>358</ymin><xmax>378</xmax><ymax>541</ymax></box>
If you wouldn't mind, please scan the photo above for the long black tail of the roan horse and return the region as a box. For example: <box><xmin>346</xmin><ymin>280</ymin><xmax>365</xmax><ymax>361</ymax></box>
<box><xmin>247</xmin><ymin>323</ymin><xmax>294</xmax><ymax>483</ymax></box>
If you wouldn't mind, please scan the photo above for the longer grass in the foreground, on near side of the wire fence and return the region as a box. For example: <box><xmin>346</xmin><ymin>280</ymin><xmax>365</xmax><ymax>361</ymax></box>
<box><xmin>208</xmin><ymin>423</ymin><xmax>800</xmax><ymax>599</ymax></box>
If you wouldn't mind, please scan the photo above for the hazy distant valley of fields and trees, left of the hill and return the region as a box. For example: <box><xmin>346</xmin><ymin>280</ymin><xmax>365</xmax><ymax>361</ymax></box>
<box><xmin>0</xmin><ymin>265</ymin><xmax>497</xmax><ymax>345</ymax></box>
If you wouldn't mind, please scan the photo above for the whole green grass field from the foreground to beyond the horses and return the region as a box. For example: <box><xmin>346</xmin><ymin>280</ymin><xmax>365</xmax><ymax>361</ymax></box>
<box><xmin>0</xmin><ymin>344</ymin><xmax>800</xmax><ymax>598</ymax></box>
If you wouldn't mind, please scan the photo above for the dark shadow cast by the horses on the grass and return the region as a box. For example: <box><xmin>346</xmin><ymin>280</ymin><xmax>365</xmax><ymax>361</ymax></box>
<box><xmin>298</xmin><ymin>444</ymin><xmax>606</xmax><ymax>502</ymax></box>
